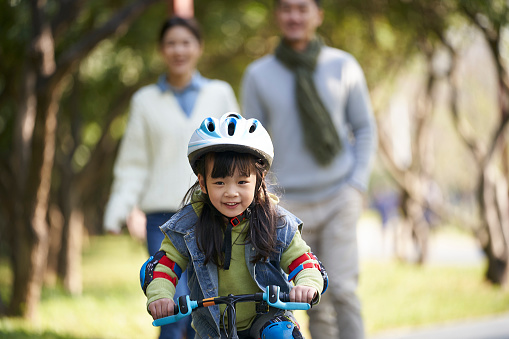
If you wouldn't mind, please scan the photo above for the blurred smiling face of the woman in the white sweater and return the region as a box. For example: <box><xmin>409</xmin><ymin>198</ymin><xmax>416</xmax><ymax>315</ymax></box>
<box><xmin>160</xmin><ymin>26</ymin><xmax>202</xmax><ymax>77</ymax></box>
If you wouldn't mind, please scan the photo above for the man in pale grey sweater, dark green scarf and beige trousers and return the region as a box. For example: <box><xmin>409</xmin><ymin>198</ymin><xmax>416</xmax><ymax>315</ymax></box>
<box><xmin>241</xmin><ymin>0</ymin><xmax>377</xmax><ymax>339</ymax></box>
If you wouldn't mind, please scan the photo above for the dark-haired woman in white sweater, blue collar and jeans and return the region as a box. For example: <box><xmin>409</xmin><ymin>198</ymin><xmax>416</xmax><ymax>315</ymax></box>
<box><xmin>104</xmin><ymin>17</ymin><xmax>239</xmax><ymax>339</ymax></box>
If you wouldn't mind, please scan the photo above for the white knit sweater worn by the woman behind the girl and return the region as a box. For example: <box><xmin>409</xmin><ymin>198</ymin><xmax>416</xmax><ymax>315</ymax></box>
<box><xmin>104</xmin><ymin>80</ymin><xmax>239</xmax><ymax>231</ymax></box>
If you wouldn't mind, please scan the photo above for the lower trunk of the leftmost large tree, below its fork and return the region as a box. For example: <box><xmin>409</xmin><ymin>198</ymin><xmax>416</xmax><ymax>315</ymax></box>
<box><xmin>10</xmin><ymin>78</ymin><xmax>61</xmax><ymax>318</ymax></box>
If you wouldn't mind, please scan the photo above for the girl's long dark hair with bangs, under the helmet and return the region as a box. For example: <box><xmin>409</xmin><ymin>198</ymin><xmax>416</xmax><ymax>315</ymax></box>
<box><xmin>182</xmin><ymin>152</ymin><xmax>278</xmax><ymax>267</ymax></box>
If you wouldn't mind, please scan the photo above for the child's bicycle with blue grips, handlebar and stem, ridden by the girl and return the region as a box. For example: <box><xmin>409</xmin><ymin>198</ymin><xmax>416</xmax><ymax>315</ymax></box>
<box><xmin>152</xmin><ymin>285</ymin><xmax>311</xmax><ymax>339</ymax></box>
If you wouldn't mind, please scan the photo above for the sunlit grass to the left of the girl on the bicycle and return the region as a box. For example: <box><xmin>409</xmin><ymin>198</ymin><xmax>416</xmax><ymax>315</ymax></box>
<box><xmin>0</xmin><ymin>236</ymin><xmax>157</xmax><ymax>339</ymax></box>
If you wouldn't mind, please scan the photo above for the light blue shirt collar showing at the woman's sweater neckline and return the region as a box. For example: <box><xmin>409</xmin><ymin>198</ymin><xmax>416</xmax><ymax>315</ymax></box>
<box><xmin>157</xmin><ymin>72</ymin><xmax>210</xmax><ymax>117</ymax></box>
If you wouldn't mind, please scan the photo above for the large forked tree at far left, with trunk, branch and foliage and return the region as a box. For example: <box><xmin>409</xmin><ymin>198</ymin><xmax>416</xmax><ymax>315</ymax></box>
<box><xmin>0</xmin><ymin>0</ymin><xmax>162</xmax><ymax>318</ymax></box>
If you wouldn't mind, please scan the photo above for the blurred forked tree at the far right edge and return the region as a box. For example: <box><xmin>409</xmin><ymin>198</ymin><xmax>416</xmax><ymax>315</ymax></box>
<box><xmin>441</xmin><ymin>0</ymin><xmax>509</xmax><ymax>286</ymax></box>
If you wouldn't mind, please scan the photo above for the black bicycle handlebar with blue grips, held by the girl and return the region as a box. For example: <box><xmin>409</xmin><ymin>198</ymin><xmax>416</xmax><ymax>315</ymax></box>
<box><xmin>152</xmin><ymin>285</ymin><xmax>311</xmax><ymax>326</ymax></box>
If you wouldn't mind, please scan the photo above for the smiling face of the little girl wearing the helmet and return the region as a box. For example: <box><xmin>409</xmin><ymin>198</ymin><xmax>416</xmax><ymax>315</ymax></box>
<box><xmin>198</xmin><ymin>158</ymin><xmax>256</xmax><ymax>218</ymax></box>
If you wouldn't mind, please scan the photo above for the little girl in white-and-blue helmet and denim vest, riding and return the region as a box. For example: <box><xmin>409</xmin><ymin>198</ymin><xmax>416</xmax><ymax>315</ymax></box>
<box><xmin>144</xmin><ymin>113</ymin><xmax>324</xmax><ymax>338</ymax></box>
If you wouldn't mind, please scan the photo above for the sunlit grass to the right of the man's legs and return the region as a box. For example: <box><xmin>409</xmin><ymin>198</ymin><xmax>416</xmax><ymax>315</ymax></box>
<box><xmin>359</xmin><ymin>262</ymin><xmax>509</xmax><ymax>333</ymax></box>
